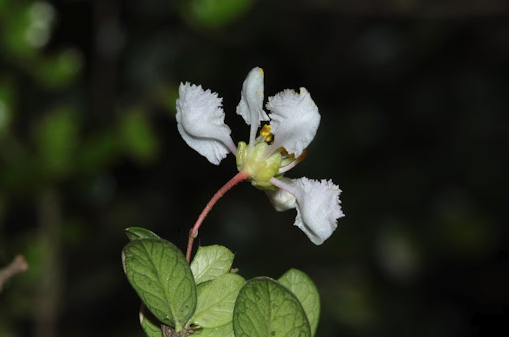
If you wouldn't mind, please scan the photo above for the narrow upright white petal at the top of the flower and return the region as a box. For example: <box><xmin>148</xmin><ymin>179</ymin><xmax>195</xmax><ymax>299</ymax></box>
<box><xmin>237</xmin><ymin>67</ymin><xmax>269</xmax><ymax>128</ymax></box>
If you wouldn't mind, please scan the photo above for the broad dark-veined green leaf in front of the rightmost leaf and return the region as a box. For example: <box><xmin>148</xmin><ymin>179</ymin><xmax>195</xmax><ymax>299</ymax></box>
<box><xmin>233</xmin><ymin>277</ymin><xmax>311</xmax><ymax>337</ymax></box>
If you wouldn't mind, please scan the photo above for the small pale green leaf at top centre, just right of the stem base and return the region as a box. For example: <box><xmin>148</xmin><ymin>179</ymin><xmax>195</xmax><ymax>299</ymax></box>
<box><xmin>191</xmin><ymin>245</ymin><xmax>234</xmax><ymax>284</ymax></box>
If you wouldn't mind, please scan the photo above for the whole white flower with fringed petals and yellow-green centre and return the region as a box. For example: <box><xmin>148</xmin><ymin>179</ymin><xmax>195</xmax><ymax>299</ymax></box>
<box><xmin>176</xmin><ymin>67</ymin><xmax>344</xmax><ymax>245</ymax></box>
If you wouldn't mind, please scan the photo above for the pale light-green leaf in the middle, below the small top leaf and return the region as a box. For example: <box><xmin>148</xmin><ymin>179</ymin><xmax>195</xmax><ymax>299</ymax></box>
<box><xmin>191</xmin><ymin>274</ymin><xmax>245</xmax><ymax>328</ymax></box>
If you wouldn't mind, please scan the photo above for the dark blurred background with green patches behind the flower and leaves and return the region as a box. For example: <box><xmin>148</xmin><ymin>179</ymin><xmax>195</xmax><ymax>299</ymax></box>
<box><xmin>0</xmin><ymin>0</ymin><xmax>509</xmax><ymax>337</ymax></box>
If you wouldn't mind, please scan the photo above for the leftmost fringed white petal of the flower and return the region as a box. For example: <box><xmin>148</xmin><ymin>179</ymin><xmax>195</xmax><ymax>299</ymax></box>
<box><xmin>176</xmin><ymin>82</ymin><xmax>235</xmax><ymax>165</ymax></box>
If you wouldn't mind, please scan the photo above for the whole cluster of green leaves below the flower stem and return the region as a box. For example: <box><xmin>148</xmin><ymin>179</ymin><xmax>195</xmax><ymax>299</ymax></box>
<box><xmin>122</xmin><ymin>227</ymin><xmax>320</xmax><ymax>337</ymax></box>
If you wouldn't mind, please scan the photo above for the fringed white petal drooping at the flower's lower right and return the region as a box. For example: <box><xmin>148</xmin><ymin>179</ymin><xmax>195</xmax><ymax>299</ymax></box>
<box><xmin>292</xmin><ymin>177</ymin><xmax>345</xmax><ymax>245</ymax></box>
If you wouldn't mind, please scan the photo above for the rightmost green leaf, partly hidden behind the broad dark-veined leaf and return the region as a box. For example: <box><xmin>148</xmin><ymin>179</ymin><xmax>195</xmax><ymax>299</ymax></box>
<box><xmin>278</xmin><ymin>269</ymin><xmax>320</xmax><ymax>336</ymax></box>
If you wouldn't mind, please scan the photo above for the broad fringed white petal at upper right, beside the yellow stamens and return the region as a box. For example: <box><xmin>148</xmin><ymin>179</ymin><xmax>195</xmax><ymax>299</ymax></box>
<box><xmin>266</xmin><ymin>88</ymin><xmax>320</xmax><ymax>157</ymax></box>
